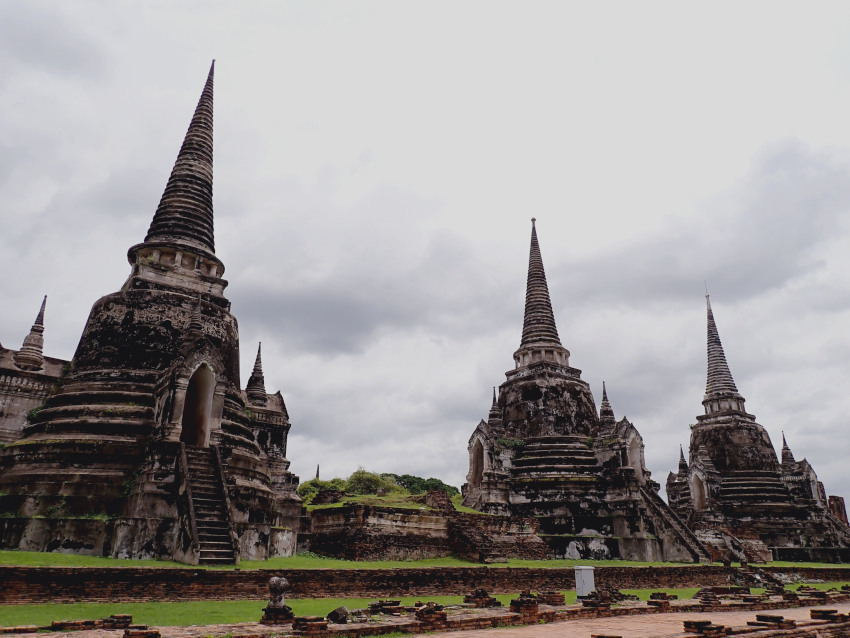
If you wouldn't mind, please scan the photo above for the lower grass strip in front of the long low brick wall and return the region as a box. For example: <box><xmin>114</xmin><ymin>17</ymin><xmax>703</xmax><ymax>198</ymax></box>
<box><xmin>0</xmin><ymin>588</ymin><xmax>708</xmax><ymax>627</ymax></box>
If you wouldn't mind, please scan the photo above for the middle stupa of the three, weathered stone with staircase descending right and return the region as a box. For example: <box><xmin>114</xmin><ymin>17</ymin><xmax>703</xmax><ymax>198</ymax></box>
<box><xmin>463</xmin><ymin>219</ymin><xmax>709</xmax><ymax>561</ymax></box>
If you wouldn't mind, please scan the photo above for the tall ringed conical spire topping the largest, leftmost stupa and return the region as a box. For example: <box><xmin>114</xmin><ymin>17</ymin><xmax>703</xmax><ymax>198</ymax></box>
<box><xmin>145</xmin><ymin>60</ymin><xmax>215</xmax><ymax>254</ymax></box>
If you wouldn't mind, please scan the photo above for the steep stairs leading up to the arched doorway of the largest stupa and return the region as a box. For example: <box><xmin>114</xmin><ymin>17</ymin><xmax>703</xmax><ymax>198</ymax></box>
<box><xmin>186</xmin><ymin>445</ymin><xmax>236</xmax><ymax>565</ymax></box>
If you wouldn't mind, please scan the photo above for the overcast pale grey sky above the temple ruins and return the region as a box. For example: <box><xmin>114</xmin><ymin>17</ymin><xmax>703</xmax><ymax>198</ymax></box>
<box><xmin>0</xmin><ymin>0</ymin><xmax>850</xmax><ymax>497</ymax></box>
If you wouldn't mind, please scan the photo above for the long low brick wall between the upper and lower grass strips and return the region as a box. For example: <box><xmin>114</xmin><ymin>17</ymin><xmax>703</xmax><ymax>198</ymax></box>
<box><xmin>0</xmin><ymin>566</ymin><xmax>736</xmax><ymax>604</ymax></box>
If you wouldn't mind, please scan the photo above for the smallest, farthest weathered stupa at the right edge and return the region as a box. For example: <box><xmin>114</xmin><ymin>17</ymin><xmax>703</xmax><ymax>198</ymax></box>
<box><xmin>667</xmin><ymin>295</ymin><xmax>850</xmax><ymax>562</ymax></box>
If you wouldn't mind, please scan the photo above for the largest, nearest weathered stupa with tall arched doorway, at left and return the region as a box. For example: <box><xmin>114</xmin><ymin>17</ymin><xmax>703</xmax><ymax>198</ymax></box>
<box><xmin>0</xmin><ymin>67</ymin><xmax>301</xmax><ymax>564</ymax></box>
